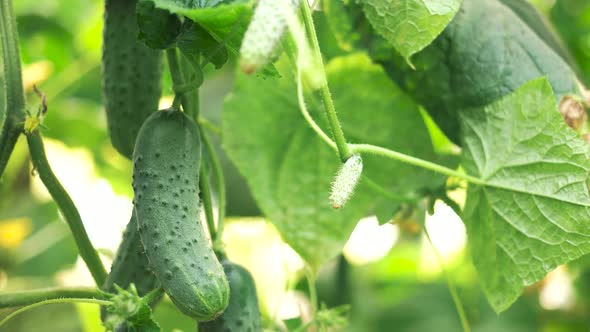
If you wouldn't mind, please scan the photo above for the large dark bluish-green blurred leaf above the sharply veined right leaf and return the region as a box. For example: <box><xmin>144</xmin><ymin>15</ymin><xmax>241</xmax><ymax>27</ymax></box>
<box><xmin>379</xmin><ymin>0</ymin><xmax>578</xmax><ymax>143</ymax></box>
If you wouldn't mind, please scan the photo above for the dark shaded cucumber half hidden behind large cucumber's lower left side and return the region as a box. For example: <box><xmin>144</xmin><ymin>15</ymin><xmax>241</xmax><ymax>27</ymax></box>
<box><xmin>101</xmin><ymin>211</ymin><xmax>158</xmax><ymax>321</ymax></box>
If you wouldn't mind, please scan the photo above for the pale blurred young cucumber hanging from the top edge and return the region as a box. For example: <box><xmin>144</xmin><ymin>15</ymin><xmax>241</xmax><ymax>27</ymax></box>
<box><xmin>240</xmin><ymin>0</ymin><xmax>300</xmax><ymax>74</ymax></box>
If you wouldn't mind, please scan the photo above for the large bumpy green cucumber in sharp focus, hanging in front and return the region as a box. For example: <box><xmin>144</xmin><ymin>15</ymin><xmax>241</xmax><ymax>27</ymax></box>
<box><xmin>133</xmin><ymin>110</ymin><xmax>229</xmax><ymax>321</ymax></box>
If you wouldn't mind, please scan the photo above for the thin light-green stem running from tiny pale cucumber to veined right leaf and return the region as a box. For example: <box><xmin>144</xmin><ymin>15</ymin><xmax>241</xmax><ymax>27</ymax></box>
<box><xmin>350</xmin><ymin>144</ymin><xmax>486</xmax><ymax>186</ymax></box>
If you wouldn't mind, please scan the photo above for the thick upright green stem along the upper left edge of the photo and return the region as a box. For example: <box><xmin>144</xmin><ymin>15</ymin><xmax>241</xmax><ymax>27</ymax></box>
<box><xmin>0</xmin><ymin>0</ymin><xmax>25</xmax><ymax>177</ymax></box>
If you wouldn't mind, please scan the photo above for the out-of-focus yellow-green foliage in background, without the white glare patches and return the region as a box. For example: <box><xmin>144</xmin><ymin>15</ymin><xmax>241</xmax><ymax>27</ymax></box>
<box><xmin>0</xmin><ymin>0</ymin><xmax>590</xmax><ymax>332</ymax></box>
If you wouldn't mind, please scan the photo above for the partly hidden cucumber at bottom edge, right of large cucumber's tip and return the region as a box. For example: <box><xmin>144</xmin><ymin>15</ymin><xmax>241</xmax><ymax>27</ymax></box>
<box><xmin>198</xmin><ymin>261</ymin><xmax>262</xmax><ymax>332</ymax></box>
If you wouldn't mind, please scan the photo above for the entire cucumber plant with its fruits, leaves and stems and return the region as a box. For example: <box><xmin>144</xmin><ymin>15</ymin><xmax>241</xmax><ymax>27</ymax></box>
<box><xmin>0</xmin><ymin>0</ymin><xmax>590</xmax><ymax>332</ymax></box>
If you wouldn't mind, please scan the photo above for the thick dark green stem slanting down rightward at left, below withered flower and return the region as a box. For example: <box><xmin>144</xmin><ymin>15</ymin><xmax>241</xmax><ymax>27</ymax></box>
<box><xmin>27</xmin><ymin>130</ymin><xmax>107</xmax><ymax>287</ymax></box>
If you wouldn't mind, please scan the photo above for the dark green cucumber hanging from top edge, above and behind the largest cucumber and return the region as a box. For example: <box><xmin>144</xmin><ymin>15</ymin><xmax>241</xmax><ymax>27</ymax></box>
<box><xmin>102</xmin><ymin>0</ymin><xmax>162</xmax><ymax>159</ymax></box>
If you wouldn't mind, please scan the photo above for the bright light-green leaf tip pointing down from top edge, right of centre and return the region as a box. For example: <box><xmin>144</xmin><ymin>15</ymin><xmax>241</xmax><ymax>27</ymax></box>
<box><xmin>361</xmin><ymin>0</ymin><xmax>461</xmax><ymax>61</ymax></box>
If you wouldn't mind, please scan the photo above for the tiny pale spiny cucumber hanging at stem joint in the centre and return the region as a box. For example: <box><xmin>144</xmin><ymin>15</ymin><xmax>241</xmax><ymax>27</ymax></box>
<box><xmin>330</xmin><ymin>155</ymin><xmax>363</xmax><ymax>209</ymax></box>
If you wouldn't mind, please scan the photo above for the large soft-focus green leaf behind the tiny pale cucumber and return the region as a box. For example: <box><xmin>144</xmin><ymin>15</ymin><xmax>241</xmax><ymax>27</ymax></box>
<box><xmin>223</xmin><ymin>55</ymin><xmax>456</xmax><ymax>267</ymax></box>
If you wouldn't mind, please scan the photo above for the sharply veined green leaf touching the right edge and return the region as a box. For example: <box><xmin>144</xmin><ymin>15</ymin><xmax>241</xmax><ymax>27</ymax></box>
<box><xmin>461</xmin><ymin>78</ymin><xmax>590</xmax><ymax>312</ymax></box>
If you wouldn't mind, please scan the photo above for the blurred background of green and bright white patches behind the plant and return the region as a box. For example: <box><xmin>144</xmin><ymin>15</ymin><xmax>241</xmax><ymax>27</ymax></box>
<box><xmin>0</xmin><ymin>0</ymin><xmax>590</xmax><ymax>332</ymax></box>
